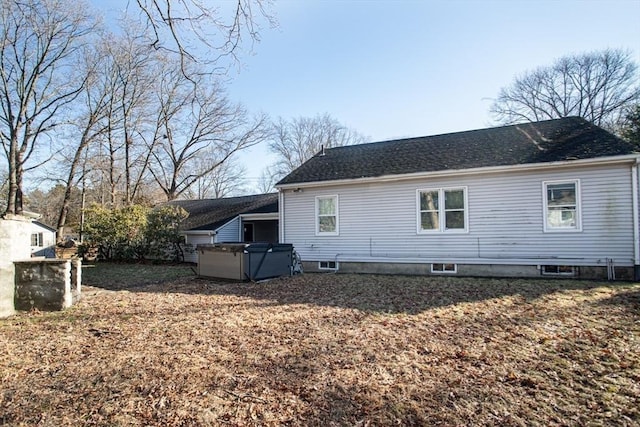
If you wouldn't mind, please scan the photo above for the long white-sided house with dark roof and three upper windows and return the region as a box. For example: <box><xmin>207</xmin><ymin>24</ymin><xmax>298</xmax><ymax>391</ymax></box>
<box><xmin>276</xmin><ymin>117</ymin><xmax>640</xmax><ymax>280</ymax></box>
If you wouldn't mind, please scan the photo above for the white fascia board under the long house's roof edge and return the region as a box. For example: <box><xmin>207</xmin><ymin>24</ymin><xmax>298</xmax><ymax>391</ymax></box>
<box><xmin>276</xmin><ymin>154</ymin><xmax>640</xmax><ymax>190</ymax></box>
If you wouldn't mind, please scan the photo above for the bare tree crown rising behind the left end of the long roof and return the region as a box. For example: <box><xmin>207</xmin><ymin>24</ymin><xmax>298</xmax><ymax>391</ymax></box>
<box><xmin>269</xmin><ymin>114</ymin><xmax>367</xmax><ymax>181</ymax></box>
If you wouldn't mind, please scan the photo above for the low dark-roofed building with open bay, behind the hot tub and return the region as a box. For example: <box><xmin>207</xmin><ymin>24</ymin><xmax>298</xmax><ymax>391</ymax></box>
<box><xmin>170</xmin><ymin>193</ymin><xmax>278</xmax><ymax>262</ymax></box>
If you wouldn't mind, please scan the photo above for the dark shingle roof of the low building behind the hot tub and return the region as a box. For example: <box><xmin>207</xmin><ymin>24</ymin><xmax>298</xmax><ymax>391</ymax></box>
<box><xmin>168</xmin><ymin>193</ymin><xmax>278</xmax><ymax>230</ymax></box>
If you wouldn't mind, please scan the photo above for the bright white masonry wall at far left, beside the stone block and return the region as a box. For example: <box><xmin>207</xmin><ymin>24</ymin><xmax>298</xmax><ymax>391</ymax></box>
<box><xmin>0</xmin><ymin>216</ymin><xmax>31</xmax><ymax>317</ymax></box>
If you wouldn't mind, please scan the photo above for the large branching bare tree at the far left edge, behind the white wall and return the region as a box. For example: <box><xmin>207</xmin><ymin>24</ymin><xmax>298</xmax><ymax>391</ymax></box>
<box><xmin>0</xmin><ymin>0</ymin><xmax>93</xmax><ymax>214</ymax></box>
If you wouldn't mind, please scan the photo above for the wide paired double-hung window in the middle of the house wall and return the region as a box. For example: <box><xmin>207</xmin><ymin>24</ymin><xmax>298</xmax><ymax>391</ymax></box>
<box><xmin>417</xmin><ymin>187</ymin><xmax>468</xmax><ymax>233</ymax></box>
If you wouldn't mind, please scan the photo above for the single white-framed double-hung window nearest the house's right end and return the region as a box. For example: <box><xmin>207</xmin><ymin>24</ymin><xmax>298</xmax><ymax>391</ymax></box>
<box><xmin>542</xmin><ymin>180</ymin><xmax>582</xmax><ymax>231</ymax></box>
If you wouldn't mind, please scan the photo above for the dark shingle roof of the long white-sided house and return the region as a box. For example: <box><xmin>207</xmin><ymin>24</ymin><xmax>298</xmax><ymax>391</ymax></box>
<box><xmin>277</xmin><ymin>117</ymin><xmax>634</xmax><ymax>185</ymax></box>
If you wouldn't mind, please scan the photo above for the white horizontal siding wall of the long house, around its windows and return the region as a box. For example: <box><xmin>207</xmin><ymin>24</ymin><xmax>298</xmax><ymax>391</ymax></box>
<box><xmin>280</xmin><ymin>164</ymin><xmax>634</xmax><ymax>266</ymax></box>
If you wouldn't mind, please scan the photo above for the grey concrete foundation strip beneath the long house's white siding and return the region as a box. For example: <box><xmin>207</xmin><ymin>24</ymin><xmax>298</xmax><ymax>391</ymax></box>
<box><xmin>302</xmin><ymin>261</ymin><xmax>634</xmax><ymax>280</ymax></box>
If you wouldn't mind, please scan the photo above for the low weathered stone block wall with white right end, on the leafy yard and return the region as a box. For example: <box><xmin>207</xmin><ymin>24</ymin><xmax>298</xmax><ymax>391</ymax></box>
<box><xmin>15</xmin><ymin>259</ymin><xmax>81</xmax><ymax>311</ymax></box>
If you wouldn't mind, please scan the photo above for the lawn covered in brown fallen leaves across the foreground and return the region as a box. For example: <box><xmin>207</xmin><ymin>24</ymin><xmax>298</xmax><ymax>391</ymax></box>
<box><xmin>0</xmin><ymin>264</ymin><xmax>640</xmax><ymax>426</ymax></box>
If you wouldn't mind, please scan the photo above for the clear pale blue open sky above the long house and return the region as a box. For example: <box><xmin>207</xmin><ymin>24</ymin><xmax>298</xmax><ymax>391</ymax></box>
<box><xmin>99</xmin><ymin>0</ymin><xmax>640</xmax><ymax>192</ymax></box>
